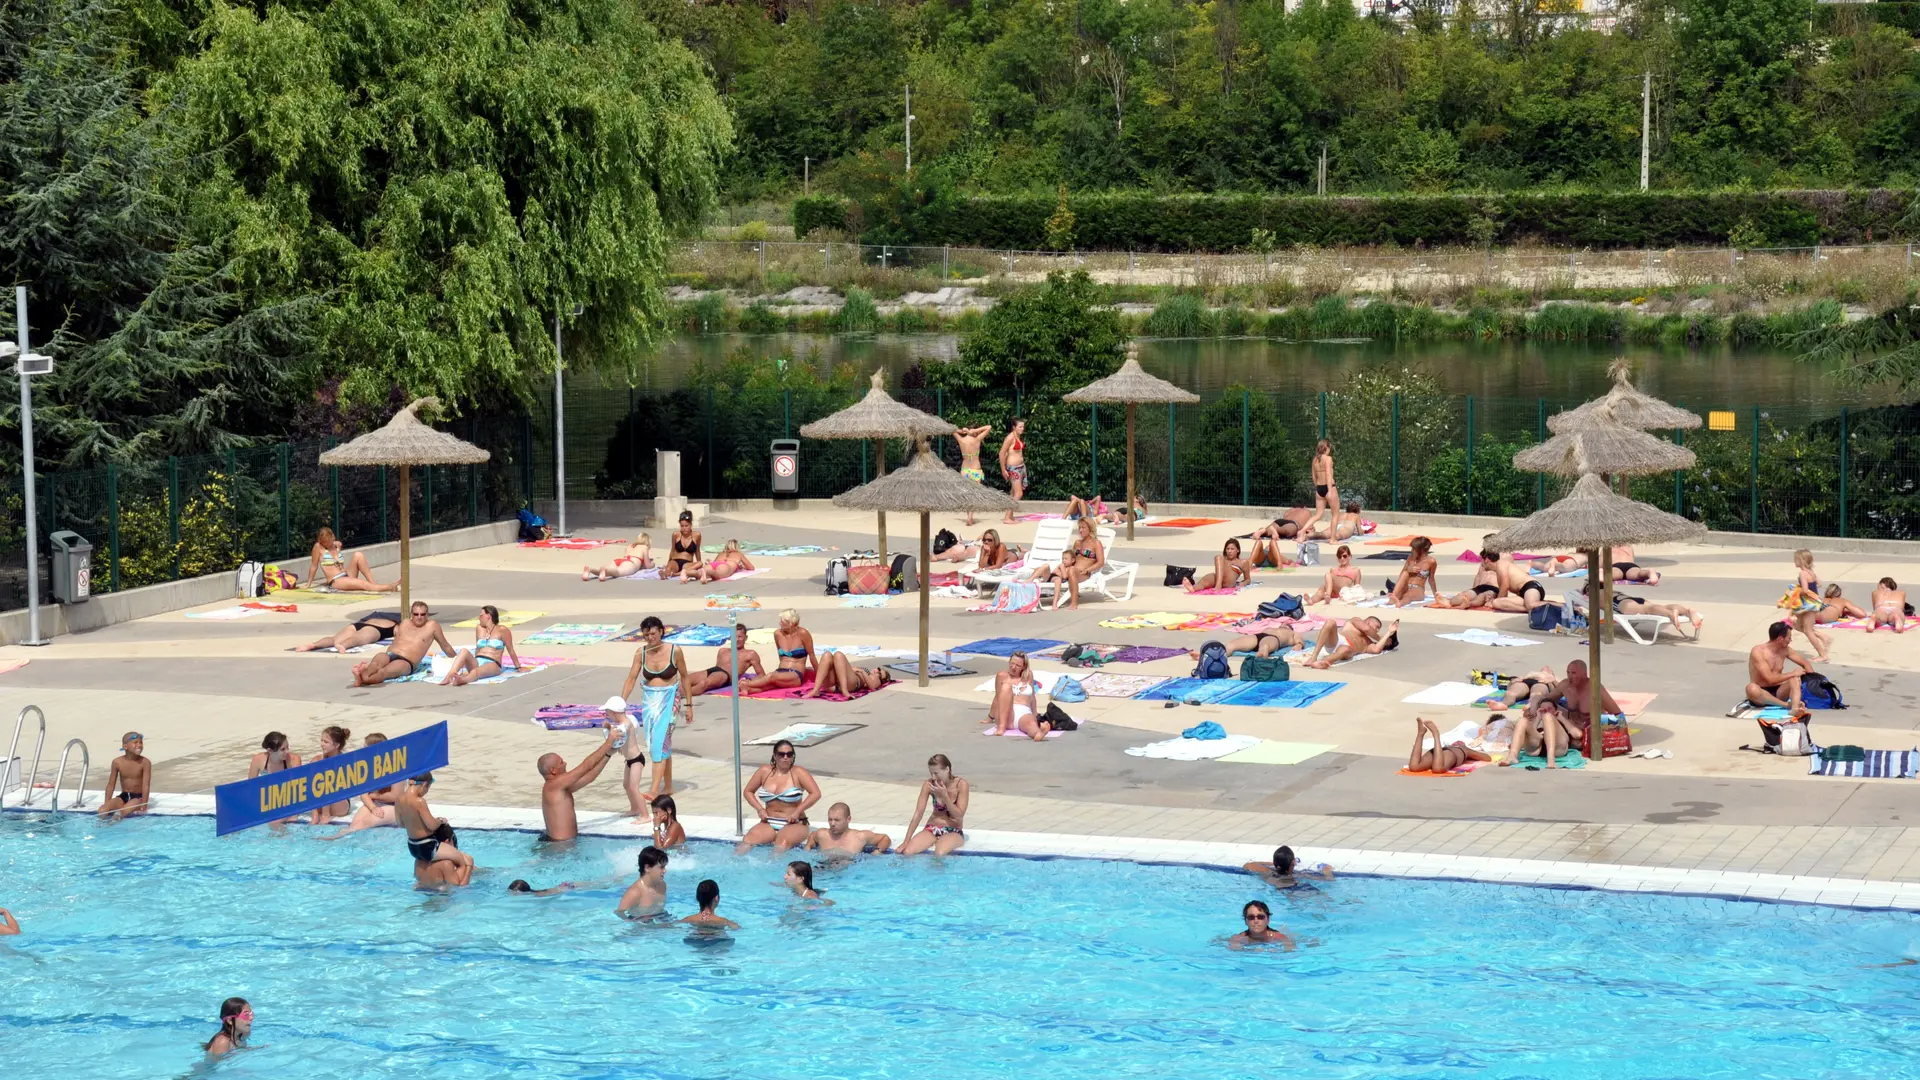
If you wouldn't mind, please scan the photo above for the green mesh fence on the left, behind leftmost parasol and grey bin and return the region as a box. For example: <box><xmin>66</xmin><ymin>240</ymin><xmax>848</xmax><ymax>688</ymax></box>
<box><xmin>0</xmin><ymin>417</ymin><xmax>532</xmax><ymax>609</ymax></box>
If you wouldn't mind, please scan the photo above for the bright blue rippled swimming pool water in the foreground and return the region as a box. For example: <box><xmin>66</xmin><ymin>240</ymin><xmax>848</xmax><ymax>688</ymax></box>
<box><xmin>0</xmin><ymin>813</ymin><xmax>1920</xmax><ymax>1080</ymax></box>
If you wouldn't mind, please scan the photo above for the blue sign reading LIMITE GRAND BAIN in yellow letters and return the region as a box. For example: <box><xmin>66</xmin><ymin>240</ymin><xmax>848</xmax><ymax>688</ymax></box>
<box><xmin>213</xmin><ymin>721</ymin><xmax>447</xmax><ymax>836</ymax></box>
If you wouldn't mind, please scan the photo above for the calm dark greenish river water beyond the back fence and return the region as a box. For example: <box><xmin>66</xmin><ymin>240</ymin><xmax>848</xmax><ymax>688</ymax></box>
<box><xmin>641</xmin><ymin>334</ymin><xmax>1893</xmax><ymax>411</ymax></box>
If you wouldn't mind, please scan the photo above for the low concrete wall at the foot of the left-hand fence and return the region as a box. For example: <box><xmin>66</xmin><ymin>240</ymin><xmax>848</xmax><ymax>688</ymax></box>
<box><xmin>0</xmin><ymin>521</ymin><xmax>520</xmax><ymax>646</ymax></box>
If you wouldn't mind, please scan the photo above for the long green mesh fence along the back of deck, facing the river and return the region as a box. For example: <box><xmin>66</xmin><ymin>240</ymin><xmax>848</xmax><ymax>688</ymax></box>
<box><xmin>530</xmin><ymin>379</ymin><xmax>1920</xmax><ymax>540</ymax></box>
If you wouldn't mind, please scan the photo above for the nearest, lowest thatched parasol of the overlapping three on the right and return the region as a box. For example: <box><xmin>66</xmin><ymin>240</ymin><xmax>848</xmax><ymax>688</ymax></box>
<box><xmin>1484</xmin><ymin>475</ymin><xmax>1707</xmax><ymax>761</ymax></box>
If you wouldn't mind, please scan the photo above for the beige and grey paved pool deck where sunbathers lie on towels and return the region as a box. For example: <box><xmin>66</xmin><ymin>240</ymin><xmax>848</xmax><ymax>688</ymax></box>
<box><xmin>0</xmin><ymin>507</ymin><xmax>1920</xmax><ymax>895</ymax></box>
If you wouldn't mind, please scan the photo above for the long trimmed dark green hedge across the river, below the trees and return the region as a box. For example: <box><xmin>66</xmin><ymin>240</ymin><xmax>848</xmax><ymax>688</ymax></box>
<box><xmin>793</xmin><ymin>190</ymin><xmax>1914</xmax><ymax>252</ymax></box>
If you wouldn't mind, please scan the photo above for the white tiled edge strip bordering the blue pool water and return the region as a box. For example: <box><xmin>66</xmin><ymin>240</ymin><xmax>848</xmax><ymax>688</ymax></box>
<box><xmin>15</xmin><ymin>792</ymin><xmax>1920</xmax><ymax>911</ymax></box>
